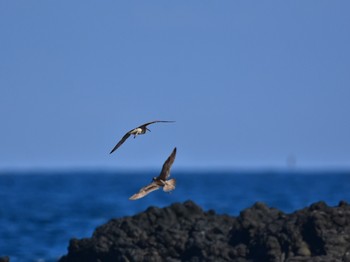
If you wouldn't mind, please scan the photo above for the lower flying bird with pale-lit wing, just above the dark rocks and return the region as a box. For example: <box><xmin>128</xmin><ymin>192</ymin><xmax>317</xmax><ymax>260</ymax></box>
<box><xmin>129</xmin><ymin>147</ymin><xmax>176</xmax><ymax>200</ymax></box>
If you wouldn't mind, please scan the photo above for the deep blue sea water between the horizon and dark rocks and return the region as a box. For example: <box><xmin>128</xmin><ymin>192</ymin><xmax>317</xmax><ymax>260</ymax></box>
<box><xmin>0</xmin><ymin>171</ymin><xmax>350</xmax><ymax>262</ymax></box>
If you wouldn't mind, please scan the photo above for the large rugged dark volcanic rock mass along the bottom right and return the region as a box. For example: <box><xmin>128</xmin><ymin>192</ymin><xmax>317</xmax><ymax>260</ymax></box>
<box><xmin>60</xmin><ymin>201</ymin><xmax>350</xmax><ymax>262</ymax></box>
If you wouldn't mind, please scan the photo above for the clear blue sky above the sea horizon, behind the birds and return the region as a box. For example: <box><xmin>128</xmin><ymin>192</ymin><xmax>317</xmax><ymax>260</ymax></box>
<box><xmin>0</xmin><ymin>0</ymin><xmax>350</xmax><ymax>170</ymax></box>
